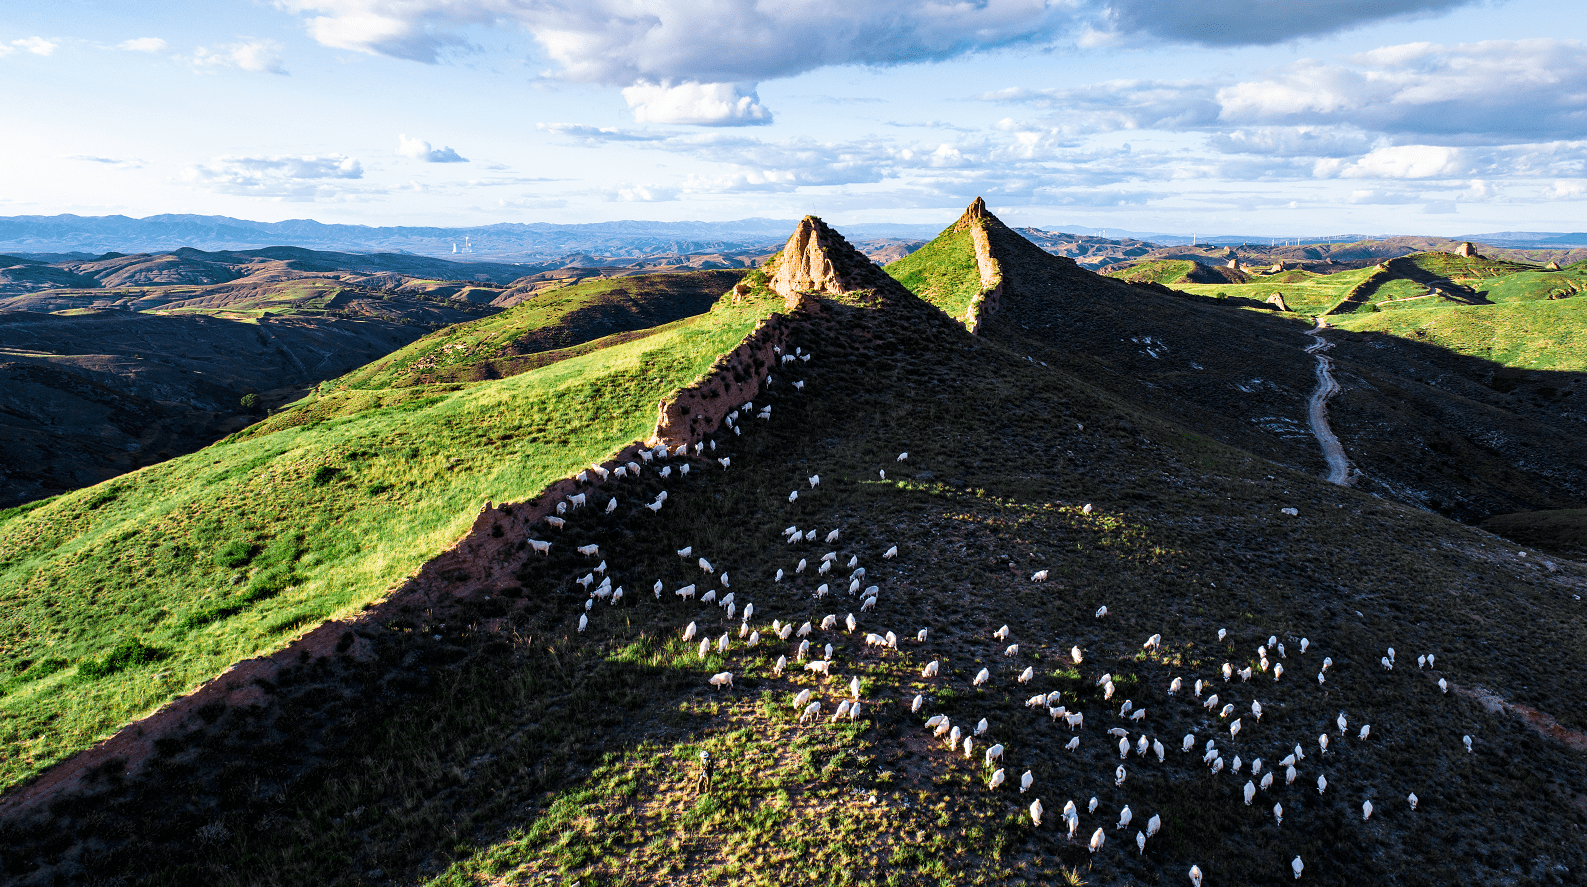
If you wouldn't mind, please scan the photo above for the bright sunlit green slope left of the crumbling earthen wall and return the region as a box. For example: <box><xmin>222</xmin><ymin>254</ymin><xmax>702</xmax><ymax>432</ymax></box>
<box><xmin>0</xmin><ymin>279</ymin><xmax>781</xmax><ymax>785</ymax></box>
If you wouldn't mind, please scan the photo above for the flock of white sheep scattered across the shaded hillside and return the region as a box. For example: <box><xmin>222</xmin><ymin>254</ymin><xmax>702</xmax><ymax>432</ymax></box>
<box><xmin>514</xmin><ymin>349</ymin><xmax>1473</xmax><ymax>887</ymax></box>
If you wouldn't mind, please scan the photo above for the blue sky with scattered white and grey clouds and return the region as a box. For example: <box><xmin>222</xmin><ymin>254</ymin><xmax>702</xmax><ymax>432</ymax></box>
<box><xmin>0</xmin><ymin>0</ymin><xmax>1587</xmax><ymax>236</ymax></box>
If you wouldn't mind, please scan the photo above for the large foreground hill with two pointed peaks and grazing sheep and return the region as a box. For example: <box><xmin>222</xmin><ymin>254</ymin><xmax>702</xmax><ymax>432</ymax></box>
<box><xmin>0</xmin><ymin>209</ymin><xmax>1587</xmax><ymax>885</ymax></box>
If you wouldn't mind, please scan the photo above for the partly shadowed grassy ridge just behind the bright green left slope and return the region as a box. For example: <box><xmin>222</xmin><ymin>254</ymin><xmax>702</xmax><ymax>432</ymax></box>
<box><xmin>338</xmin><ymin>271</ymin><xmax>743</xmax><ymax>389</ymax></box>
